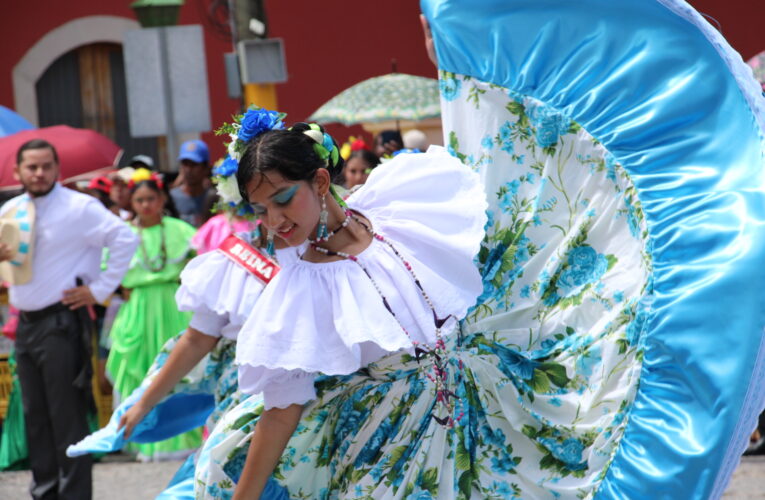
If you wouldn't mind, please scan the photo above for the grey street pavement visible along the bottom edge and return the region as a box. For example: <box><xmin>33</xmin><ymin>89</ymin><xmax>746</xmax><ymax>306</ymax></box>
<box><xmin>0</xmin><ymin>456</ymin><xmax>765</xmax><ymax>500</ymax></box>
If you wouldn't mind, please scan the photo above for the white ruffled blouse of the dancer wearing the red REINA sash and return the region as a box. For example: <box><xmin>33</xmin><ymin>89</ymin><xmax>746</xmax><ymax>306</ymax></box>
<box><xmin>175</xmin><ymin>242</ymin><xmax>301</xmax><ymax>340</ymax></box>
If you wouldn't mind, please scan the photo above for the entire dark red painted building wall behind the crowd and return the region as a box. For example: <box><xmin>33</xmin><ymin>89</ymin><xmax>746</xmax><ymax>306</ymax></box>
<box><xmin>0</xmin><ymin>0</ymin><xmax>765</xmax><ymax>155</ymax></box>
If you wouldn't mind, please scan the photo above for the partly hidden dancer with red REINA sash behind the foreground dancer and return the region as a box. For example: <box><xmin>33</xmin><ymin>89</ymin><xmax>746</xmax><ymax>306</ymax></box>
<box><xmin>69</xmin><ymin>111</ymin><xmax>299</xmax><ymax>499</ymax></box>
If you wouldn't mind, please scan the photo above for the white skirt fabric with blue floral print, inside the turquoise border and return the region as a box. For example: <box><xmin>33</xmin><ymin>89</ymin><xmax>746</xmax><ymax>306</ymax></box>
<box><xmin>196</xmin><ymin>73</ymin><xmax>652</xmax><ymax>500</ymax></box>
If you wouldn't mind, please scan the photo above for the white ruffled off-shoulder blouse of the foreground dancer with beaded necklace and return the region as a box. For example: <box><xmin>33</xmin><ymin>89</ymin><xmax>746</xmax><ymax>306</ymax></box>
<box><xmin>236</xmin><ymin>147</ymin><xmax>486</xmax><ymax>408</ymax></box>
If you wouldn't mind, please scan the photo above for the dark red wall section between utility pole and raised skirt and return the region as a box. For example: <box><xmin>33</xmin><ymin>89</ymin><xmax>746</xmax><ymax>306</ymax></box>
<box><xmin>266</xmin><ymin>0</ymin><xmax>437</xmax><ymax>145</ymax></box>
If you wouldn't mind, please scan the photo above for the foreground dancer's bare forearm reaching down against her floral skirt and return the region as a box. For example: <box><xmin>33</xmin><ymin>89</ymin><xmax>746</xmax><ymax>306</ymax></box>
<box><xmin>233</xmin><ymin>405</ymin><xmax>303</xmax><ymax>500</ymax></box>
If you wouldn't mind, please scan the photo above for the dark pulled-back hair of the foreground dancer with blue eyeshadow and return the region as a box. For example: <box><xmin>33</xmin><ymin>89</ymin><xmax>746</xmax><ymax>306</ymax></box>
<box><xmin>236</xmin><ymin>123</ymin><xmax>344</xmax><ymax>200</ymax></box>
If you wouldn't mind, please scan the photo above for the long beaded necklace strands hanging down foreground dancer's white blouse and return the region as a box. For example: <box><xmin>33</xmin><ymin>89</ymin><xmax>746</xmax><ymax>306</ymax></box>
<box><xmin>311</xmin><ymin>217</ymin><xmax>464</xmax><ymax>427</ymax></box>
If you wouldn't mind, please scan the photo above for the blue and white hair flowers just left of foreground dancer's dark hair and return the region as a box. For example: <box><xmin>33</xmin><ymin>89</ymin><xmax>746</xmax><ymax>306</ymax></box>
<box><xmin>213</xmin><ymin>106</ymin><xmax>287</xmax><ymax>216</ymax></box>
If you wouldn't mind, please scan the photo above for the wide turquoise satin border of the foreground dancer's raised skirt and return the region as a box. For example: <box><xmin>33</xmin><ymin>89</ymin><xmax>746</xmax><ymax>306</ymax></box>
<box><xmin>421</xmin><ymin>0</ymin><xmax>765</xmax><ymax>499</ymax></box>
